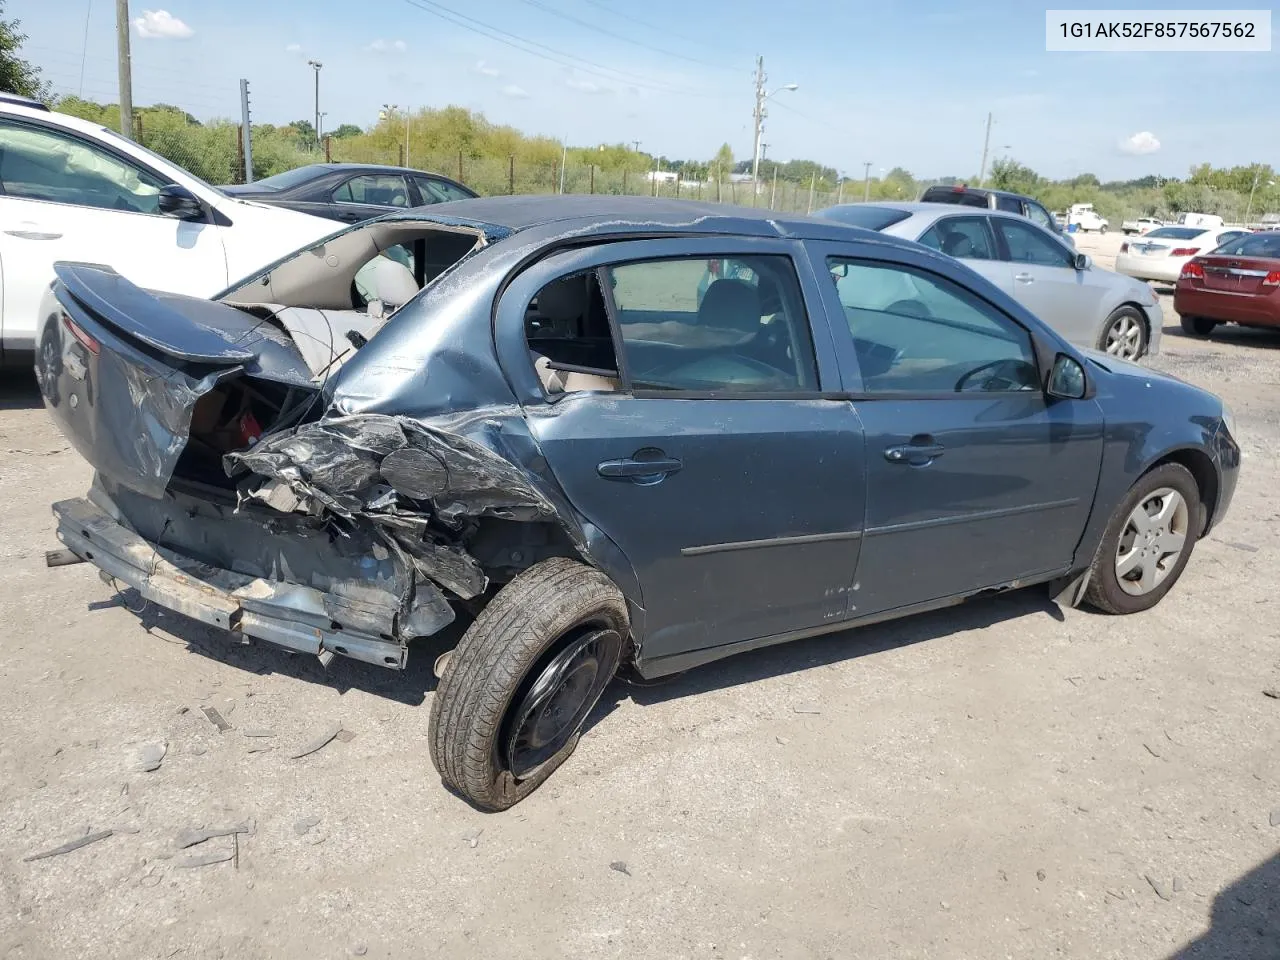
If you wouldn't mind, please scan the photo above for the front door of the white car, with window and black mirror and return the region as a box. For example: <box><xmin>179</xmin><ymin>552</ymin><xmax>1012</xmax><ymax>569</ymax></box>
<box><xmin>0</xmin><ymin>118</ymin><xmax>228</xmax><ymax>358</ymax></box>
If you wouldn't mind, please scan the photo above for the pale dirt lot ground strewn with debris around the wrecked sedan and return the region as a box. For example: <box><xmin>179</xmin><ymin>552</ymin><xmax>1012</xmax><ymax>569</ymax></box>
<box><xmin>0</xmin><ymin>229</ymin><xmax>1280</xmax><ymax>960</ymax></box>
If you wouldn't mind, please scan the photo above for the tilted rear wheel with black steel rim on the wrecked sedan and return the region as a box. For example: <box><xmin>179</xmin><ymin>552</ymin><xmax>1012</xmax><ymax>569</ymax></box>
<box><xmin>429</xmin><ymin>557</ymin><xmax>630</xmax><ymax>810</ymax></box>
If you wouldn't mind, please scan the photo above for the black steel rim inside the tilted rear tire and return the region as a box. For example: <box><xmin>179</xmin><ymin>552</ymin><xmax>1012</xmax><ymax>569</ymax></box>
<box><xmin>506</xmin><ymin>630</ymin><xmax>622</xmax><ymax>780</ymax></box>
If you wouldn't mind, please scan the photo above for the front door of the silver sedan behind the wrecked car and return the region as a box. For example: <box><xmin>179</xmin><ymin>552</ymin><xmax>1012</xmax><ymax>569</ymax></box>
<box><xmin>991</xmin><ymin>216</ymin><xmax>1106</xmax><ymax>347</ymax></box>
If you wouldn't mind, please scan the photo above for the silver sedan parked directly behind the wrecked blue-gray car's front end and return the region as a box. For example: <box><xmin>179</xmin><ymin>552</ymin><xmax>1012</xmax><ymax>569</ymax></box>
<box><xmin>817</xmin><ymin>202</ymin><xmax>1164</xmax><ymax>360</ymax></box>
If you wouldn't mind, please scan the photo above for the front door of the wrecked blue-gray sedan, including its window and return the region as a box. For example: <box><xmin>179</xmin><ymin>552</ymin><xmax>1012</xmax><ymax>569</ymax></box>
<box><xmin>829</xmin><ymin>257</ymin><xmax>1102</xmax><ymax>618</ymax></box>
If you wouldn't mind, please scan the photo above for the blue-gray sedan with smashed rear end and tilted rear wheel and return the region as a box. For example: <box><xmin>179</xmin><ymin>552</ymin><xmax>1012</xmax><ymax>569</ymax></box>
<box><xmin>36</xmin><ymin>197</ymin><xmax>1240</xmax><ymax>809</ymax></box>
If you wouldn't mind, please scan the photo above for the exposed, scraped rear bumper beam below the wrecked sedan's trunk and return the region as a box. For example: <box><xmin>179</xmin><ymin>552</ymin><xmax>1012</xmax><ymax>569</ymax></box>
<box><xmin>54</xmin><ymin>498</ymin><xmax>408</xmax><ymax>669</ymax></box>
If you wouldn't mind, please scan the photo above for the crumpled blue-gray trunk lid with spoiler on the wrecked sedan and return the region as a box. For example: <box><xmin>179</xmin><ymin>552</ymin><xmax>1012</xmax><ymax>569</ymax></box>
<box><xmin>36</xmin><ymin>264</ymin><xmax>319</xmax><ymax>497</ymax></box>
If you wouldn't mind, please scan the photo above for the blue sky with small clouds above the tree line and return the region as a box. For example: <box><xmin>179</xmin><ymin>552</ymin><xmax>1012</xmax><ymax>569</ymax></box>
<box><xmin>6</xmin><ymin>0</ymin><xmax>1280</xmax><ymax>179</ymax></box>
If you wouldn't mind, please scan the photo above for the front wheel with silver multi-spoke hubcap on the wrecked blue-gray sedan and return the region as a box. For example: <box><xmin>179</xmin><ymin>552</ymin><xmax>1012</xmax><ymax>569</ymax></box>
<box><xmin>1084</xmin><ymin>463</ymin><xmax>1204</xmax><ymax>613</ymax></box>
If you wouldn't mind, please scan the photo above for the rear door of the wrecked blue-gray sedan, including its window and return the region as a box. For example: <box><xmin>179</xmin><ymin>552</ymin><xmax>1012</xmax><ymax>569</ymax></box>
<box><xmin>498</xmin><ymin>238</ymin><xmax>864</xmax><ymax>659</ymax></box>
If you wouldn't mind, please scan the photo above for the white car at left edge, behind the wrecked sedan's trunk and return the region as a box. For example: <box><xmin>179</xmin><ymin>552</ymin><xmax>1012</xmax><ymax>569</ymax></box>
<box><xmin>0</xmin><ymin>93</ymin><xmax>337</xmax><ymax>366</ymax></box>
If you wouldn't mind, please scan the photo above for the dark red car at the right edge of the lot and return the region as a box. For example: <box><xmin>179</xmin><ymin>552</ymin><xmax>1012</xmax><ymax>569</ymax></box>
<box><xmin>1174</xmin><ymin>232</ymin><xmax>1280</xmax><ymax>337</ymax></box>
